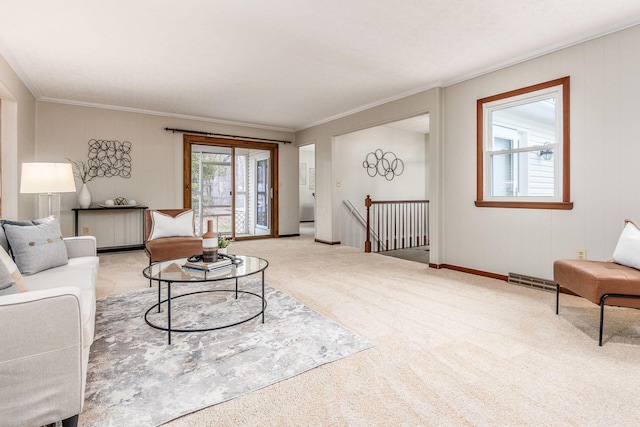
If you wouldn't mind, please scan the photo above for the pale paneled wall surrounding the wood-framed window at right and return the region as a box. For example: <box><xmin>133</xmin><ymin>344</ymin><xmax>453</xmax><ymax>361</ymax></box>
<box><xmin>442</xmin><ymin>26</ymin><xmax>640</xmax><ymax>279</ymax></box>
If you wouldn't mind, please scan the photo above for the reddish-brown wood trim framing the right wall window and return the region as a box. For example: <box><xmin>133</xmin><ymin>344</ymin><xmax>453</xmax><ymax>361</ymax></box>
<box><xmin>475</xmin><ymin>76</ymin><xmax>573</xmax><ymax>210</ymax></box>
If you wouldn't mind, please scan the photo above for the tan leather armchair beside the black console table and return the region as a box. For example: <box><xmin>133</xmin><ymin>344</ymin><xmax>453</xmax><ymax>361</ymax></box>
<box><xmin>144</xmin><ymin>209</ymin><xmax>202</xmax><ymax>286</ymax></box>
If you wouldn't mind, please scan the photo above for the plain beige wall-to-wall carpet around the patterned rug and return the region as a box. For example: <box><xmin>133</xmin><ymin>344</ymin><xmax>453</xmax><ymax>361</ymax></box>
<box><xmin>98</xmin><ymin>231</ymin><xmax>640</xmax><ymax>427</ymax></box>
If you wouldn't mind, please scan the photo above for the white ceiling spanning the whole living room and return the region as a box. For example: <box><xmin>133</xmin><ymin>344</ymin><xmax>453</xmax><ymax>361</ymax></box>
<box><xmin>0</xmin><ymin>0</ymin><xmax>640</xmax><ymax>130</ymax></box>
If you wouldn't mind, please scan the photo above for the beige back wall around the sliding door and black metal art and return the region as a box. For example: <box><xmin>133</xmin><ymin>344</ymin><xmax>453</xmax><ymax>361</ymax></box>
<box><xmin>37</xmin><ymin>102</ymin><xmax>298</xmax><ymax>246</ymax></box>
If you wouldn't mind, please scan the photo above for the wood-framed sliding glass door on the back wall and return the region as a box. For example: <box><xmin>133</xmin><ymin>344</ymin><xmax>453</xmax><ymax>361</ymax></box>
<box><xmin>183</xmin><ymin>135</ymin><xmax>278</xmax><ymax>240</ymax></box>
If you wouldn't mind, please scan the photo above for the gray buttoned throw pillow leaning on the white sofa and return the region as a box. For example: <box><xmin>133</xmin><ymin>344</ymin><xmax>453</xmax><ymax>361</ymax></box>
<box><xmin>4</xmin><ymin>221</ymin><xmax>69</xmax><ymax>275</ymax></box>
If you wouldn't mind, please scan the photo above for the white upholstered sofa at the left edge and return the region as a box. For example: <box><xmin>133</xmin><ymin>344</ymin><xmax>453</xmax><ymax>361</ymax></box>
<box><xmin>0</xmin><ymin>234</ymin><xmax>99</xmax><ymax>426</ymax></box>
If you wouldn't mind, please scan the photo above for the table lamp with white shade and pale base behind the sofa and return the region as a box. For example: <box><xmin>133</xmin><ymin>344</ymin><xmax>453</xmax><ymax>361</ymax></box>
<box><xmin>20</xmin><ymin>162</ymin><xmax>76</xmax><ymax>219</ymax></box>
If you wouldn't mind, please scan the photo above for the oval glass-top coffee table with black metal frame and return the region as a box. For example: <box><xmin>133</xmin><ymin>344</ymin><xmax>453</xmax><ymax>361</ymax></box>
<box><xmin>142</xmin><ymin>255</ymin><xmax>269</xmax><ymax>344</ymax></box>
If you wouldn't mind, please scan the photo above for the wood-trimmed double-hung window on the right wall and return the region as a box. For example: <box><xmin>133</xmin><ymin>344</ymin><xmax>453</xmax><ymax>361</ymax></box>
<box><xmin>476</xmin><ymin>77</ymin><xmax>573</xmax><ymax>209</ymax></box>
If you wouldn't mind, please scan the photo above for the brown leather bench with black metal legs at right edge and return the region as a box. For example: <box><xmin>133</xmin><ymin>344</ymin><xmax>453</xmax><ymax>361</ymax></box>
<box><xmin>553</xmin><ymin>259</ymin><xmax>640</xmax><ymax>346</ymax></box>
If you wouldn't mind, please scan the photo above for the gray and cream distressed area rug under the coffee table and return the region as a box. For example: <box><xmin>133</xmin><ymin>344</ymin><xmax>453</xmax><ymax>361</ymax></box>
<box><xmin>80</xmin><ymin>280</ymin><xmax>371</xmax><ymax>426</ymax></box>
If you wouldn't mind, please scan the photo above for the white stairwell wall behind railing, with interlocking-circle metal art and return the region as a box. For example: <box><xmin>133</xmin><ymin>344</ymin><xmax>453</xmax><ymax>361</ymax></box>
<box><xmin>332</xmin><ymin>126</ymin><xmax>427</xmax><ymax>249</ymax></box>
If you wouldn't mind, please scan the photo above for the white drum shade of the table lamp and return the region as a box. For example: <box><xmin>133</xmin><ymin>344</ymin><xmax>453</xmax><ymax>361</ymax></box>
<box><xmin>20</xmin><ymin>163</ymin><xmax>76</xmax><ymax>194</ymax></box>
